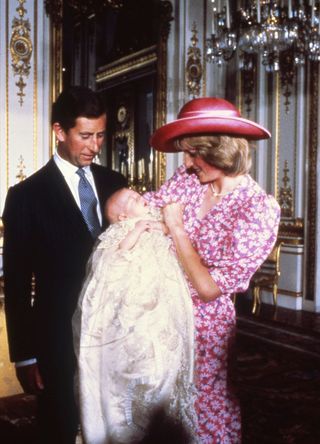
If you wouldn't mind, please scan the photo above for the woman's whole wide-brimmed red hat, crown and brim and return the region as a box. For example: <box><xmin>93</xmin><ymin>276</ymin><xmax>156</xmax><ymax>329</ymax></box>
<box><xmin>150</xmin><ymin>97</ymin><xmax>271</xmax><ymax>153</ymax></box>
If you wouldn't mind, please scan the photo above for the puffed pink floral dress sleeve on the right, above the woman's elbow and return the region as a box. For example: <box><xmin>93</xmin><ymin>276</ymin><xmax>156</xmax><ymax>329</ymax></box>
<box><xmin>208</xmin><ymin>195</ymin><xmax>280</xmax><ymax>293</ymax></box>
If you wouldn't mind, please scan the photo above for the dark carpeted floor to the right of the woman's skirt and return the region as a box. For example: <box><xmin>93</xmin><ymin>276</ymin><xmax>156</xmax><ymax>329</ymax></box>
<box><xmin>237</xmin><ymin>333</ymin><xmax>320</xmax><ymax>444</ymax></box>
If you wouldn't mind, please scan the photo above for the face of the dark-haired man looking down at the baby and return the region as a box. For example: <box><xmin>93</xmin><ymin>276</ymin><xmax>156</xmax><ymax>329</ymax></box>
<box><xmin>53</xmin><ymin>114</ymin><xmax>107</xmax><ymax>167</ymax></box>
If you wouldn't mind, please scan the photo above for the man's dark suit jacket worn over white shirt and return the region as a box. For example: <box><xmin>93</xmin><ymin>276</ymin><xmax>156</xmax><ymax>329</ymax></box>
<box><xmin>3</xmin><ymin>159</ymin><xmax>126</xmax><ymax>366</ymax></box>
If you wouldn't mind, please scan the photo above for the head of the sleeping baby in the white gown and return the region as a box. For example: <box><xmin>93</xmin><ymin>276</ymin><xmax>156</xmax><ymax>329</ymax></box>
<box><xmin>105</xmin><ymin>188</ymin><xmax>148</xmax><ymax>224</ymax></box>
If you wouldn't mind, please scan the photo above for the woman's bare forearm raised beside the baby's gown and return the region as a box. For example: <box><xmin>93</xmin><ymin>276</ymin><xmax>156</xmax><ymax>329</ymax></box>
<box><xmin>163</xmin><ymin>203</ymin><xmax>221</xmax><ymax>302</ymax></box>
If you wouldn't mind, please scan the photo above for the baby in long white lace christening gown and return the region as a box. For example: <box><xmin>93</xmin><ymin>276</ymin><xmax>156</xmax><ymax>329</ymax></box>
<box><xmin>73</xmin><ymin>188</ymin><xmax>196</xmax><ymax>444</ymax></box>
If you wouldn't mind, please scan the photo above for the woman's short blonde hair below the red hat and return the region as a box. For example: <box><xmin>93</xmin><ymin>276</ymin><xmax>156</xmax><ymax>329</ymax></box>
<box><xmin>177</xmin><ymin>134</ymin><xmax>252</xmax><ymax>176</ymax></box>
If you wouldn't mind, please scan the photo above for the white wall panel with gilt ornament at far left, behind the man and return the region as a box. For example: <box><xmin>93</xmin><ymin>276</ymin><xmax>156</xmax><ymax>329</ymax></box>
<box><xmin>0</xmin><ymin>0</ymin><xmax>50</xmax><ymax>212</ymax></box>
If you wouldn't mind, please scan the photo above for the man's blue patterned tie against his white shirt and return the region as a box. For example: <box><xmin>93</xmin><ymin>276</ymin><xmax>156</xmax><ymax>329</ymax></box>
<box><xmin>77</xmin><ymin>168</ymin><xmax>101</xmax><ymax>239</ymax></box>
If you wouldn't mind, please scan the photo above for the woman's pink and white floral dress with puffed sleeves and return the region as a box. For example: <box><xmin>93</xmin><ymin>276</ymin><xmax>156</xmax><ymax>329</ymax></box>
<box><xmin>145</xmin><ymin>166</ymin><xmax>280</xmax><ymax>444</ymax></box>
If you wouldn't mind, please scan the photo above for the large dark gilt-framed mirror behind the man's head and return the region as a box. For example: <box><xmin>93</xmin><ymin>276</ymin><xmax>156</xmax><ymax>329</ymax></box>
<box><xmin>46</xmin><ymin>0</ymin><xmax>172</xmax><ymax>191</ymax></box>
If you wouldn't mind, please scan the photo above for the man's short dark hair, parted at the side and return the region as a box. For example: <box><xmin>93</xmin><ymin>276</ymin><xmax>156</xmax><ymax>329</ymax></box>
<box><xmin>51</xmin><ymin>86</ymin><xmax>106</xmax><ymax>132</ymax></box>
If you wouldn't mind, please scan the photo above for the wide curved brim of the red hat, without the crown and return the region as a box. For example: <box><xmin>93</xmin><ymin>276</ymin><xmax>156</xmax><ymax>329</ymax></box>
<box><xmin>150</xmin><ymin>116</ymin><xmax>271</xmax><ymax>153</ymax></box>
